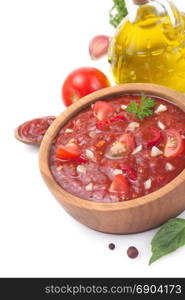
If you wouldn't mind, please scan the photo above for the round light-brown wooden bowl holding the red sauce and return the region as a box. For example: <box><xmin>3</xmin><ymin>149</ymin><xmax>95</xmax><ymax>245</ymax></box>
<box><xmin>39</xmin><ymin>83</ymin><xmax>185</xmax><ymax>234</ymax></box>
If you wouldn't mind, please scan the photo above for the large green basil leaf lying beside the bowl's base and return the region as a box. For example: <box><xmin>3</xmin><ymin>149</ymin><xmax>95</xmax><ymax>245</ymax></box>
<box><xmin>149</xmin><ymin>218</ymin><xmax>185</xmax><ymax>265</ymax></box>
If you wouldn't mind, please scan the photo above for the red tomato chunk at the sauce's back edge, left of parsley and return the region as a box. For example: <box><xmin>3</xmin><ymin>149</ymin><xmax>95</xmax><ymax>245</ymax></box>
<box><xmin>93</xmin><ymin>101</ymin><xmax>114</xmax><ymax>121</ymax></box>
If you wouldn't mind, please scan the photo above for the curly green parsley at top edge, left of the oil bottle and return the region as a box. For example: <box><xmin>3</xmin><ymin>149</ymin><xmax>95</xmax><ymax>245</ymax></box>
<box><xmin>109</xmin><ymin>0</ymin><xmax>128</xmax><ymax>27</ymax></box>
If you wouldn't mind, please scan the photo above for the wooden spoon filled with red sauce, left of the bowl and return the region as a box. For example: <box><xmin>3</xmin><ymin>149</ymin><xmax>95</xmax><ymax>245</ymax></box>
<box><xmin>15</xmin><ymin>116</ymin><xmax>56</xmax><ymax>145</ymax></box>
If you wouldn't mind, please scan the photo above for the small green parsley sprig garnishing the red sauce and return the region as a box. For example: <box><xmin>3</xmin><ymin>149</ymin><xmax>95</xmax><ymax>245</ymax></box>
<box><xmin>126</xmin><ymin>95</ymin><xmax>156</xmax><ymax>121</ymax></box>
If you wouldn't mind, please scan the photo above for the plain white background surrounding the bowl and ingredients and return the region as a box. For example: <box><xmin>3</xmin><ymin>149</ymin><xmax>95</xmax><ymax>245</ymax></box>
<box><xmin>0</xmin><ymin>0</ymin><xmax>185</xmax><ymax>277</ymax></box>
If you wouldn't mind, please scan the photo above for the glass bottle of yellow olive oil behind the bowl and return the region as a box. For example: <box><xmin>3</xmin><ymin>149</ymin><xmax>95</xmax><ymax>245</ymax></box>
<box><xmin>109</xmin><ymin>0</ymin><xmax>185</xmax><ymax>92</ymax></box>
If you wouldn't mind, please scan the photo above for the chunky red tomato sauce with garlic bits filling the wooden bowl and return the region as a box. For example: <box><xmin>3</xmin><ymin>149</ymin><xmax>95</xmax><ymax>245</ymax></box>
<box><xmin>50</xmin><ymin>95</ymin><xmax>185</xmax><ymax>202</ymax></box>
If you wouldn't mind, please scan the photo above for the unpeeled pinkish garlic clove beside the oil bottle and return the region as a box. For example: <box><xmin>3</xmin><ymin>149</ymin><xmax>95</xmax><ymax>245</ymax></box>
<box><xmin>89</xmin><ymin>35</ymin><xmax>110</xmax><ymax>59</ymax></box>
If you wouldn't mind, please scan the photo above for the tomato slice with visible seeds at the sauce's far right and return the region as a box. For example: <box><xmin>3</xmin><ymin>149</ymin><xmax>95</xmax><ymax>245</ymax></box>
<box><xmin>164</xmin><ymin>129</ymin><xmax>185</xmax><ymax>157</ymax></box>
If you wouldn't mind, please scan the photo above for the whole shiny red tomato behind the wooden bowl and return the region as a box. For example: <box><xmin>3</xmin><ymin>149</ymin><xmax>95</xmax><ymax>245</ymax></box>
<box><xmin>62</xmin><ymin>67</ymin><xmax>110</xmax><ymax>106</ymax></box>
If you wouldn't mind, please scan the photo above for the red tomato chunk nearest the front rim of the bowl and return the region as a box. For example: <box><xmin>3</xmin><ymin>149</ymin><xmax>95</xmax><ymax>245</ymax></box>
<box><xmin>109</xmin><ymin>174</ymin><xmax>129</xmax><ymax>194</ymax></box>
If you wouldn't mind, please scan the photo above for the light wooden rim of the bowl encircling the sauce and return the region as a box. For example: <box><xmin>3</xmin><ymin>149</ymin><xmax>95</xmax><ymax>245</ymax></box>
<box><xmin>39</xmin><ymin>83</ymin><xmax>185</xmax><ymax>211</ymax></box>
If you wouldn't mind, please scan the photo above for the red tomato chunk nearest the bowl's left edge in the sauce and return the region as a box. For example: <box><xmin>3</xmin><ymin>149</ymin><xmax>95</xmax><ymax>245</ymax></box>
<box><xmin>56</xmin><ymin>143</ymin><xmax>81</xmax><ymax>160</ymax></box>
